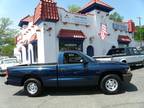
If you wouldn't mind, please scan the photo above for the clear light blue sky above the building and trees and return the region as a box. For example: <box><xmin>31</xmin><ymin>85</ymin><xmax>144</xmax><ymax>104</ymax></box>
<box><xmin>0</xmin><ymin>0</ymin><xmax>144</xmax><ymax>27</ymax></box>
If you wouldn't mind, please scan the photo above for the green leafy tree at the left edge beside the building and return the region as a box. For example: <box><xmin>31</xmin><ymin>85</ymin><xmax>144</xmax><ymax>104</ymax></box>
<box><xmin>0</xmin><ymin>18</ymin><xmax>18</xmax><ymax>57</ymax></box>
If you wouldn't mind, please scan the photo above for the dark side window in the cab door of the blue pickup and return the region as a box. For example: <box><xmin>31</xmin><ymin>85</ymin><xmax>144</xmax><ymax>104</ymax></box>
<box><xmin>64</xmin><ymin>53</ymin><xmax>83</xmax><ymax>64</ymax></box>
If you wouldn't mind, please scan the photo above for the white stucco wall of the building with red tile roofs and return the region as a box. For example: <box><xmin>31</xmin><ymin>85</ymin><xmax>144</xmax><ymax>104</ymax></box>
<box><xmin>17</xmin><ymin>8</ymin><xmax>136</xmax><ymax>63</ymax></box>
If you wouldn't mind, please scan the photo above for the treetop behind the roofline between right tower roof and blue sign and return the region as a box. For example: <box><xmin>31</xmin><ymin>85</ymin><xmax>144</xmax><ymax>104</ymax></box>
<box><xmin>109</xmin><ymin>12</ymin><xmax>124</xmax><ymax>22</ymax></box>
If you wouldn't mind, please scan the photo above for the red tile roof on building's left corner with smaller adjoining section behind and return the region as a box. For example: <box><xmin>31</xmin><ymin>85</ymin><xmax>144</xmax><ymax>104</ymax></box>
<box><xmin>19</xmin><ymin>0</ymin><xmax>59</xmax><ymax>27</ymax></box>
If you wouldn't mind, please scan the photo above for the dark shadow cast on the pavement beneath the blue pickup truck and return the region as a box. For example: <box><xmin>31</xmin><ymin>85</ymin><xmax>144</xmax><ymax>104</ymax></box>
<box><xmin>14</xmin><ymin>83</ymin><xmax>138</xmax><ymax>97</ymax></box>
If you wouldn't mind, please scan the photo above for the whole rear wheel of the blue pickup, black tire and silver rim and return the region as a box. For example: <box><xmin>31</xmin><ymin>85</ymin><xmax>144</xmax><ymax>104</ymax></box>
<box><xmin>24</xmin><ymin>78</ymin><xmax>42</xmax><ymax>97</ymax></box>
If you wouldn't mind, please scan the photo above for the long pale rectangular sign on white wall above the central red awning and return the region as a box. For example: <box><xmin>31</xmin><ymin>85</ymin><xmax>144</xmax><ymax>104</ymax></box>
<box><xmin>62</xmin><ymin>13</ymin><xmax>90</xmax><ymax>25</ymax></box>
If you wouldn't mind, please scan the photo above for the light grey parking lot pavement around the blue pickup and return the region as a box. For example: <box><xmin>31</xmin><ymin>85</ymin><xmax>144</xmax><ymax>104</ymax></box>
<box><xmin>0</xmin><ymin>68</ymin><xmax>144</xmax><ymax>108</ymax></box>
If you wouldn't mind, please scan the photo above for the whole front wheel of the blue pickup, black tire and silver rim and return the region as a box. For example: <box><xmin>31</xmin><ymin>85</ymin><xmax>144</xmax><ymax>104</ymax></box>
<box><xmin>100</xmin><ymin>74</ymin><xmax>121</xmax><ymax>94</ymax></box>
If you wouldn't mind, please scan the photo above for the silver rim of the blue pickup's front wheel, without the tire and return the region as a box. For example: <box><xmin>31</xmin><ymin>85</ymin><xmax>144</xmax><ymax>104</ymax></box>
<box><xmin>105</xmin><ymin>79</ymin><xmax>118</xmax><ymax>92</ymax></box>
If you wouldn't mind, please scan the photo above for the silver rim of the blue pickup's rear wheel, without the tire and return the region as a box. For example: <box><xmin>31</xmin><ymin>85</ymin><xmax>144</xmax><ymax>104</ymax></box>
<box><xmin>27</xmin><ymin>82</ymin><xmax>38</xmax><ymax>95</ymax></box>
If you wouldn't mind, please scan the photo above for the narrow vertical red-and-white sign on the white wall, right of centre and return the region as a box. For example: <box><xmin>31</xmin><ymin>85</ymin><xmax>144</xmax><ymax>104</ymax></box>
<box><xmin>99</xmin><ymin>24</ymin><xmax>108</xmax><ymax>40</ymax></box>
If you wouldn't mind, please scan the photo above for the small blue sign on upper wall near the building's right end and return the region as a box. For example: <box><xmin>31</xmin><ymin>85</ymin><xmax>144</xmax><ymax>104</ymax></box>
<box><xmin>113</xmin><ymin>22</ymin><xmax>128</xmax><ymax>31</ymax></box>
